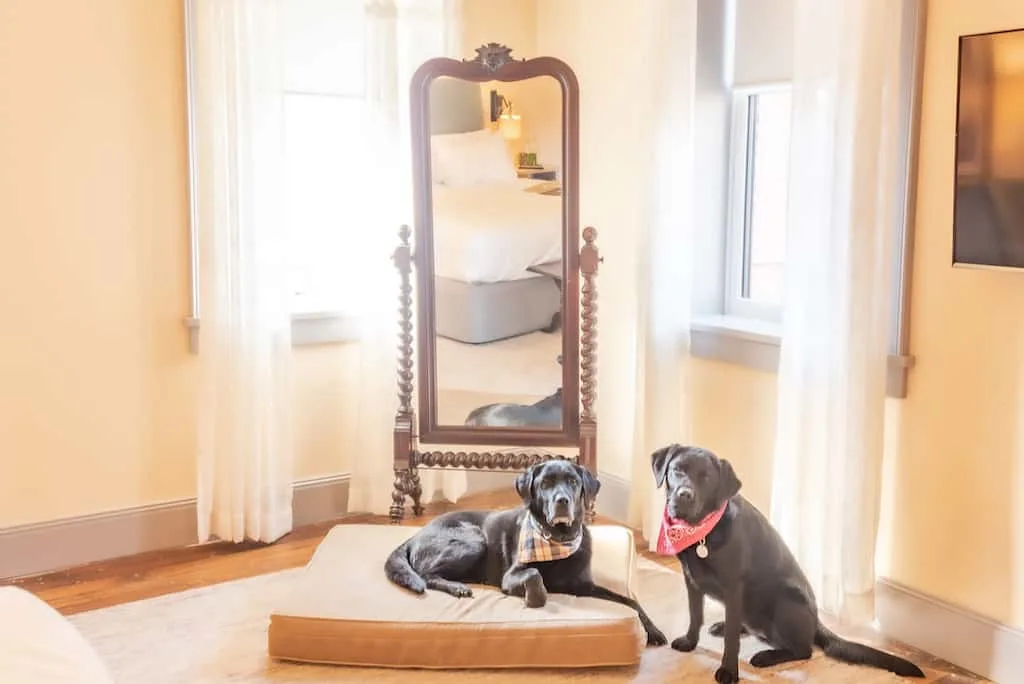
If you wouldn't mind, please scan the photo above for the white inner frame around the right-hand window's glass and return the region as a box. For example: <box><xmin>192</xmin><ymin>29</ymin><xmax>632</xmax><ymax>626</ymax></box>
<box><xmin>723</xmin><ymin>82</ymin><xmax>792</xmax><ymax>324</ymax></box>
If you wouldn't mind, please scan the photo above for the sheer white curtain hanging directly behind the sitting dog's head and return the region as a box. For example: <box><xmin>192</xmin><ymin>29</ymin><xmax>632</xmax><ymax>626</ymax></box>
<box><xmin>630</xmin><ymin>0</ymin><xmax>697</xmax><ymax>550</ymax></box>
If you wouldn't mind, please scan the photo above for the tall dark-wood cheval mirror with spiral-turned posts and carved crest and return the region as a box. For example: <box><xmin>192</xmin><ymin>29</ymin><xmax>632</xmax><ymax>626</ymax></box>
<box><xmin>391</xmin><ymin>43</ymin><xmax>600</xmax><ymax>522</ymax></box>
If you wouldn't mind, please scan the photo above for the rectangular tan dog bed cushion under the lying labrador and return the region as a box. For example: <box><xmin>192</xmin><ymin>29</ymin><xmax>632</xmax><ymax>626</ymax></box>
<box><xmin>267</xmin><ymin>524</ymin><xmax>646</xmax><ymax>670</ymax></box>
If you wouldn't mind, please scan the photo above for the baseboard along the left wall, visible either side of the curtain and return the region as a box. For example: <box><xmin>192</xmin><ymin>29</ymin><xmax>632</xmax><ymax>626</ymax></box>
<box><xmin>0</xmin><ymin>474</ymin><xmax>349</xmax><ymax>579</ymax></box>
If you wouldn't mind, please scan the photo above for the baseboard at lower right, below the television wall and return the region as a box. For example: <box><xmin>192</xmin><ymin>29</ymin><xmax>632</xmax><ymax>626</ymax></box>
<box><xmin>874</xmin><ymin>579</ymin><xmax>1024</xmax><ymax>684</ymax></box>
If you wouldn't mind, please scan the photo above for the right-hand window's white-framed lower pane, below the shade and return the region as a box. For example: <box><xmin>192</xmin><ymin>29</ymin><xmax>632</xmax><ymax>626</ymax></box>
<box><xmin>725</xmin><ymin>87</ymin><xmax>791</xmax><ymax>320</ymax></box>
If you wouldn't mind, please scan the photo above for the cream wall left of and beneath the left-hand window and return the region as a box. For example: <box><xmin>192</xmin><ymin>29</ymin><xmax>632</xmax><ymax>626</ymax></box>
<box><xmin>0</xmin><ymin>0</ymin><xmax>358</xmax><ymax>527</ymax></box>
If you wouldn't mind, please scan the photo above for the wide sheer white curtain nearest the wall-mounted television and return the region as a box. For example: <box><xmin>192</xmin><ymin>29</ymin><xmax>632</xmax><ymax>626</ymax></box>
<box><xmin>771</xmin><ymin>0</ymin><xmax>903</xmax><ymax>618</ymax></box>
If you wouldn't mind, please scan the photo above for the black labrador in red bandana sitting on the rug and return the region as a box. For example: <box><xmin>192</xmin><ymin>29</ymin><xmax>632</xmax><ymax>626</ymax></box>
<box><xmin>650</xmin><ymin>444</ymin><xmax>925</xmax><ymax>684</ymax></box>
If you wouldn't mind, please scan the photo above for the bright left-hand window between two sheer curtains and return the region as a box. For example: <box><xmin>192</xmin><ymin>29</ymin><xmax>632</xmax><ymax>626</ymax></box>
<box><xmin>282</xmin><ymin>0</ymin><xmax>366</xmax><ymax>314</ymax></box>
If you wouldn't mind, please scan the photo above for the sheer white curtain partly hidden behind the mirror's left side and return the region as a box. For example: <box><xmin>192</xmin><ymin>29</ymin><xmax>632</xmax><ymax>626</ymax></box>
<box><xmin>349</xmin><ymin>0</ymin><xmax>466</xmax><ymax>514</ymax></box>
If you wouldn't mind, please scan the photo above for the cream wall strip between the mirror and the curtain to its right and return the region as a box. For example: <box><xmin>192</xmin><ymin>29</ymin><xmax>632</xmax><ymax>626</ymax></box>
<box><xmin>537</xmin><ymin>0</ymin><xmax>650</xmax><ymax>479</ymax></box>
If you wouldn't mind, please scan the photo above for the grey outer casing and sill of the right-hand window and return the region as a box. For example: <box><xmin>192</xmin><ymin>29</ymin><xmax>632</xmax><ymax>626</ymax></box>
<box><xmin>689</xmin><ymin>0</ymin><xmax>928</xmax><ymax>399</ymax></box>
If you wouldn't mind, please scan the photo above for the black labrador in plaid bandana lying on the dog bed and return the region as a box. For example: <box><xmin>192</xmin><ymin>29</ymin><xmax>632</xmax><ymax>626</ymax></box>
<box><xmin>384</xmin><ymin>459</ymin><xmax>668</xmax><ymax>646</ymax></box>
